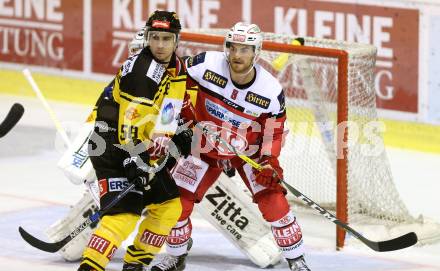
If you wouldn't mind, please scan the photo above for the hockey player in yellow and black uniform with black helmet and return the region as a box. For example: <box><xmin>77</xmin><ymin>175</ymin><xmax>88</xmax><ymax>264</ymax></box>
<box><xmin>78</xmin><ymin>11</ymin><xmax>192</xmax><ymax>271</ymax></box>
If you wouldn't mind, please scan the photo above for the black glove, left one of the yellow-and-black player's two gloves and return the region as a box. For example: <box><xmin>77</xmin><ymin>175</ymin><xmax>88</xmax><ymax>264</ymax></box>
<box><xmin>123</xmin><ymin>152</ymin><xmax>150</xmax><ymax>190</ymax></box>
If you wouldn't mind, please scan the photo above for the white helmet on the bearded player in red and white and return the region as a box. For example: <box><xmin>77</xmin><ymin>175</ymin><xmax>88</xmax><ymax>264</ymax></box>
<box><xmin>224</xmin><ymin>22</ymin><xmax>263</xmax><ymax>63</ymax></box>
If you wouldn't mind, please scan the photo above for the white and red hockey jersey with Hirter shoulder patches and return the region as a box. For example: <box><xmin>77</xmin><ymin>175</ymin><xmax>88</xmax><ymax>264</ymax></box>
<box><xmin>182</xmin><ymin>51</ymin><xmax>286</xmax><ymax>165</ymax></box>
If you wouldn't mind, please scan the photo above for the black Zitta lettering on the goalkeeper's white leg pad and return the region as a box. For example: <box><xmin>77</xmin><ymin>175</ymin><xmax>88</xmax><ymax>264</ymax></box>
<box><xmin>205</xmin><ymin>186</ymin><xmax>249</xmax><ymax>240</ymax></box>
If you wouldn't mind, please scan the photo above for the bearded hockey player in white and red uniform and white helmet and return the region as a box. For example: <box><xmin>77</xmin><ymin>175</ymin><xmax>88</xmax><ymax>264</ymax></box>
<box><xmin>151</xmin><ymin>22</ymin><xmax>310</xmax><ymax>271</ymax></box>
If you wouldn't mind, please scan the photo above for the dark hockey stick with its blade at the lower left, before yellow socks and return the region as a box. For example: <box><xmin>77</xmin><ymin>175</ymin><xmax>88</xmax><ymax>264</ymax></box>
<box><xmin>18</xmin><ymin>182</ymin><xmax>136</xmax><ymax>253</ymax></box>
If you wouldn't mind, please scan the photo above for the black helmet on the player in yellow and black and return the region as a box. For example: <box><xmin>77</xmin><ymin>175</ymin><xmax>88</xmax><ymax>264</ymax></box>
<box><xmin>145</xmin><ymin>10</ymin><xmax>182</xmax><ymax>35</ymax></box>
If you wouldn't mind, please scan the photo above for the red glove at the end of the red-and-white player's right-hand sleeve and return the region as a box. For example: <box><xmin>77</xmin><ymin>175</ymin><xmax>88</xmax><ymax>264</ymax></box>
<box><xmin>253</xmin><ymin>156</ymin><xmax>283</xmax><ymax>188</ymax></box>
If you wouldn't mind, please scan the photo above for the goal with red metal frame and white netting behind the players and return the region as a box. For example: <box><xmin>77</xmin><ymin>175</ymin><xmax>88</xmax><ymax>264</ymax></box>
<box><xmin>178</xmin><ymin>29</ymin><xmax>439</xmax><ymax>247</ymax></box>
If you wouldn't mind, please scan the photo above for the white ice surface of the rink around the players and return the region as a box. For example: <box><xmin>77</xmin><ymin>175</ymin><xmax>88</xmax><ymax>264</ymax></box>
<box><xmin>0</xmin><ymin>95</ymin><xmax>440</xmax><ymax>271</ymax></box>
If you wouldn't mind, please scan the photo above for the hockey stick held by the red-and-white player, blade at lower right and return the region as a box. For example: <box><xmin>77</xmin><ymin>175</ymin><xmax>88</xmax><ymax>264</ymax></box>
<box><xmin>196</xmin><ymin>123</ymin><xmax>417</xmax><ymax>252</ymax></box>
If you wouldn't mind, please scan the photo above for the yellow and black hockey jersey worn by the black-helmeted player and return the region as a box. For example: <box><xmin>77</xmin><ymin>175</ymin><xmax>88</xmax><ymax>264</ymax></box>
<box><xmin>97</xmin><ymin>48</ymin><xmax>186</xmax><ymax>156</ymax></box>
